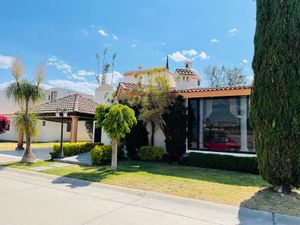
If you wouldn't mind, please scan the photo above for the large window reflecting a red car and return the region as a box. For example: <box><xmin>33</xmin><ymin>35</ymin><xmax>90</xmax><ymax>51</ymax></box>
<box><xmin>188</xmin><ymin>96</ymin><xmax>255</xmax><ymax>152</ymax></box>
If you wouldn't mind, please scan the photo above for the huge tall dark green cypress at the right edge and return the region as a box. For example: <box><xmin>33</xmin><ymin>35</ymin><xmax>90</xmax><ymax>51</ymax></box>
<box><xmin>250</xmin><ymin>0</ymin><xmax>300</xmax><ymax>193</ymax></box>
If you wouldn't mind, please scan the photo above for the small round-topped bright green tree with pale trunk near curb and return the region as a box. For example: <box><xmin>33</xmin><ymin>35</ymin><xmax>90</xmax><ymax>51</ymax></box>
<box><xmin>95</xmin><ymin>104</ymin><xmax>137</xmax><ymax>170</ymax></box>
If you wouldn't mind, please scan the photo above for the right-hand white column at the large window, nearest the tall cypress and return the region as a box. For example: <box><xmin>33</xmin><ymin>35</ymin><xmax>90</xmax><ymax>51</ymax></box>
<box><xmin>240</xmin><ymin>96</ymin><xmax>249</xmax><ymax>151</ymax></box>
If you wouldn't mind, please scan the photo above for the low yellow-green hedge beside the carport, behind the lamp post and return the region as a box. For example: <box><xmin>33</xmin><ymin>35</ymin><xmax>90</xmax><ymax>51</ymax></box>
<box><xmin>50</xmin><ymin>143</ymin><xmax>103</xmax><ymax>158</ymax></box>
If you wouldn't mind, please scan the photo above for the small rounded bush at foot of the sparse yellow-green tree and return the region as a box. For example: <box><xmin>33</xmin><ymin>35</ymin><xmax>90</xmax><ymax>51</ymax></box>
<box><xmin>138</xmin><ymin>146</ymin><xmax>164</xmax><ymax>162</ymax></box>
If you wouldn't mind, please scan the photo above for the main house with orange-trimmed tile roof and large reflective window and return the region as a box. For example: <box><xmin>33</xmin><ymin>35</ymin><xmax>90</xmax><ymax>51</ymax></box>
<box><xmin>117</xmin><ymin>62</ymin><xmax>255</xmax><ymax>154</ymax></box>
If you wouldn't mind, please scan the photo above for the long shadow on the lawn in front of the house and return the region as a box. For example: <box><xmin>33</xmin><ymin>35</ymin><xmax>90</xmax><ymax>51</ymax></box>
<box><xmin>46</xmin><ymin>161</ymin><xmax>268</xmax><ymax>187</ymax></box>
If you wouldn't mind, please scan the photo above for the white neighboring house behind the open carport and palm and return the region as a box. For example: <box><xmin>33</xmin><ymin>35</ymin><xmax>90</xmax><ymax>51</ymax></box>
<box><xmin>0</xmin><ymin>88</ymin><xmax>94</xmax><ymax>142</ymax></box>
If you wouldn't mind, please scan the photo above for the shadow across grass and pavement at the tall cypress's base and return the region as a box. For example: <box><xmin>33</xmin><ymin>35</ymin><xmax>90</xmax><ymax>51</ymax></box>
<box><xmin>239</xmin><ymin>188</ymin><xmax>300</xmax><ymax>225</ymax></box>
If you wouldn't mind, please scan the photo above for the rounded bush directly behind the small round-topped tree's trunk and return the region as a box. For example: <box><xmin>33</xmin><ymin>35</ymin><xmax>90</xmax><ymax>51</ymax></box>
<box><xmin>90</xmin><ymin>145</ymin><xmax>124</xmax><ymax>166</ymax></box>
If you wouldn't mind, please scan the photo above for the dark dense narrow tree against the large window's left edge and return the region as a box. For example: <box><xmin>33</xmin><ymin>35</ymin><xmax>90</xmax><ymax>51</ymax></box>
<box><xmin>162</xmin><ymin>96</ymin><xmax>187</xmax><ymax>161</ymax></box>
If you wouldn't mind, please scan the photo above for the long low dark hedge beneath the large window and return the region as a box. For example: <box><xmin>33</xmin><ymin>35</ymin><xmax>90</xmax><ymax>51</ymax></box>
<box><xmin>183</xmin><ymin>152</ymin><xmax>259</xmax><ymax>174</ymax></box>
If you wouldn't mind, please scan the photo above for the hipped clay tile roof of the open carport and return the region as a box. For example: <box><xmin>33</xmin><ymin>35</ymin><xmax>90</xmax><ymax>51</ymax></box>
<box><xmin>35</xmin><ymin>94</ymin><xmax>98</xmax><ymax>114</ymax></box>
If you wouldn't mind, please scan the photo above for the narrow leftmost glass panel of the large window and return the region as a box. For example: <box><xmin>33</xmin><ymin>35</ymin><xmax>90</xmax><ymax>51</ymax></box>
<box><xmin>188</xmin><ymin>99</ymin><xmax>199</xmax><ymax>149</ymax></box>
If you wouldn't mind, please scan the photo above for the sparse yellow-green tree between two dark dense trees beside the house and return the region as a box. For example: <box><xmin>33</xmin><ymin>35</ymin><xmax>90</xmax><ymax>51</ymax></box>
<box><xmin>130</xmin><ymin>73</ymin><xmax>174</xmax><ymax>146</ymax></box>
